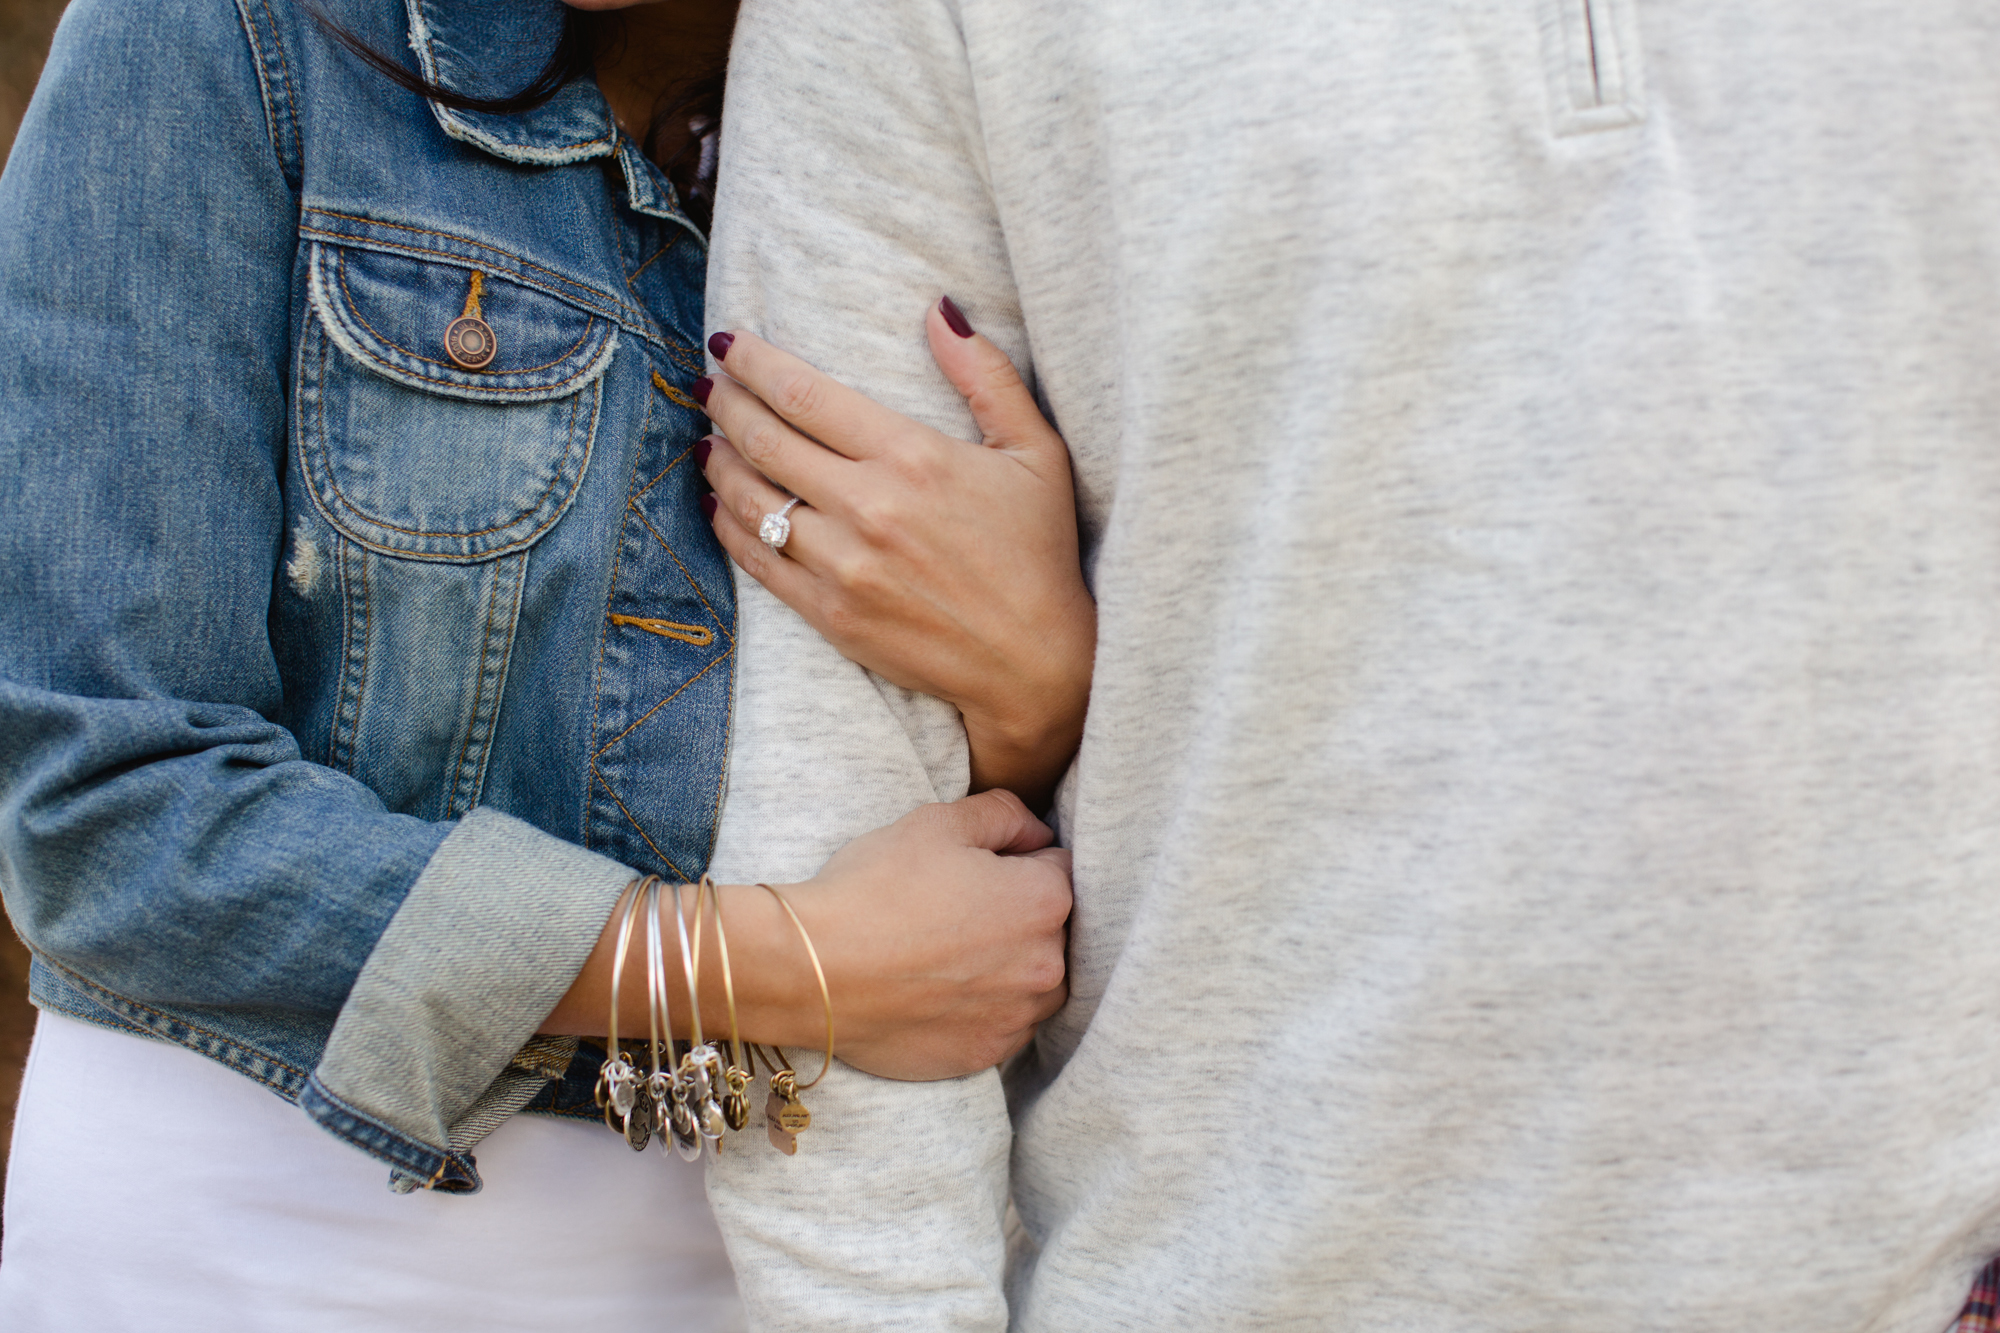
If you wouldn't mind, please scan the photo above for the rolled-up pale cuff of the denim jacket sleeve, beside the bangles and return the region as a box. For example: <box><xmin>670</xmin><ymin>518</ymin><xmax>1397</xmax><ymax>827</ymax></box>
<box><xmin>300</xmin><ymin>809</ymin><xmax>634</xmax><ymax>1191</ymax></box>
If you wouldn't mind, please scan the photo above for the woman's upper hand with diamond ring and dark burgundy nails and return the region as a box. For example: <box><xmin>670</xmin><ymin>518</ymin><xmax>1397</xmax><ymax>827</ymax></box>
<box><xmin>696</xmin><ymin>298</ymin><xmax>1098</xmax><ymax>811</ymax></box>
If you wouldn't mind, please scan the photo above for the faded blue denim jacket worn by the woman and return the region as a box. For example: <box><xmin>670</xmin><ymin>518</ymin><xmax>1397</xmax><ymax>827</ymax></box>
<box><xmin>0</xmin><ymin>0</ymin><xmax>736</xmax><ymax>1191</ymax></box>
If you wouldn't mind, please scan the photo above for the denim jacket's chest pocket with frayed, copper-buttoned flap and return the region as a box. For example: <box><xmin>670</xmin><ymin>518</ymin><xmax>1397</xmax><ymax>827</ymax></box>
<box><xmin>294</xmin><ymin>242</ymin><xmax>618</xmax><ymax>562</ymax></box>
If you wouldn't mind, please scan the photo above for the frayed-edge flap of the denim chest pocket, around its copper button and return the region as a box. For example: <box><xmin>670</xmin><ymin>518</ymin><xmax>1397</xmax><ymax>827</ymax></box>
<box><xmin>308</xmin><ymin>242</ymin><xmax>618</xmax><ymax>402</ymax></box>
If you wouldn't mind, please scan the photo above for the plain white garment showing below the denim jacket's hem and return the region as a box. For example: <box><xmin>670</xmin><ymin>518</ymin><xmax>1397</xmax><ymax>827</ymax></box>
<box><xmin>0</xmin><ymin>1013</ymin><xmax>744</xmax><ymax>1333</ymax></box>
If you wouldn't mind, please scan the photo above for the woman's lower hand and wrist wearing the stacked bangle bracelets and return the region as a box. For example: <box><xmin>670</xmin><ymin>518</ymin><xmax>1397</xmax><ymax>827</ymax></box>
<box><xmin>542</xmin><ymin>791</ymin><xmax>1070</xmax><ymax>1079</ymax></box>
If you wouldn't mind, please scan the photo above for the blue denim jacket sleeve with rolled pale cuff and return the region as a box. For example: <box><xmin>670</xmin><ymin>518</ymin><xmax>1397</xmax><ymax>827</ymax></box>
<box><xmin>0</xmin><ymin>0</ymin><xmax>626</xmax><ymax>1189</ymax></box>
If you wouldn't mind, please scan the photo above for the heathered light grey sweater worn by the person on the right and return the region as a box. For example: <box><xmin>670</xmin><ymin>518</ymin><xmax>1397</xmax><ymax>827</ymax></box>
<box><xmin>710</xmin><ymin>0</ymin><xmax>2000</xmax><ymax>1333</ymax></box>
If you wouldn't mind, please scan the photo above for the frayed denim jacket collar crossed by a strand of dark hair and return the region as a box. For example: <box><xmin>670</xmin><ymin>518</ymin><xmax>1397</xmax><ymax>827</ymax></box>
<box><xmin>404</xmin><ymin>0</ymin><xmax>618</xmax><ymax>166</ymax></box>
